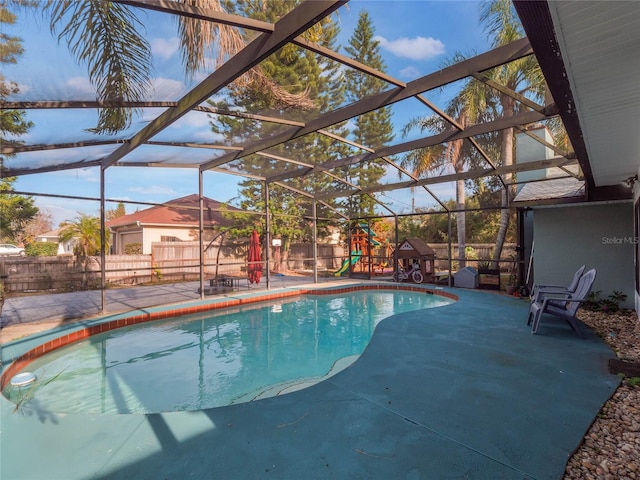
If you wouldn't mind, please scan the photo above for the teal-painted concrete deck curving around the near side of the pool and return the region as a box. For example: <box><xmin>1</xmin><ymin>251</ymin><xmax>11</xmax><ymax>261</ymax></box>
<box><xmin>0</xmin><ymin>282</ymin><xmax>619</xmax><ymax>480</ymax></box>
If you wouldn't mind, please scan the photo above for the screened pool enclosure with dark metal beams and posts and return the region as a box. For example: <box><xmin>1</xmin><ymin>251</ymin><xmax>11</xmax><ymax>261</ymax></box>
<box><xmin>0</xmin><ymin>0</ymin><xmax>629</xmax><ymax>314</ymax></box>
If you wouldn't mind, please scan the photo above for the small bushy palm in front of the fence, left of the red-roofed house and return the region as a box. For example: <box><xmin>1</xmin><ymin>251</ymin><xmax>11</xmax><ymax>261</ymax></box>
<box><xmin>60</xmin><ymin>213</ymin><xmax>109</xmax><ymax>287</ymax></box>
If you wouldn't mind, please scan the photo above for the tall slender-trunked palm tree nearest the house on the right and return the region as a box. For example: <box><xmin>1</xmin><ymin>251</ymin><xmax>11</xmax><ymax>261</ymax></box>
<box><xmin>480</xmin><ymin>0</ymin><xmax>546</xmax><ymax>265</ymax></box>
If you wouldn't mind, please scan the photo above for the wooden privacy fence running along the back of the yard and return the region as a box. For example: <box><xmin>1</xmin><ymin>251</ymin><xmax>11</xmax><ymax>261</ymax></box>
<box><xmin>0</xmin><ymin>242</ymin><xmax>515</xmax><ymax>292</ymax></box>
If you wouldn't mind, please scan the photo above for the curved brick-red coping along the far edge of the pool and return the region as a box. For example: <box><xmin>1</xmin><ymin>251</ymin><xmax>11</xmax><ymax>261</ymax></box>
<box><xmin>0</xmin><ymin>283</ymin><xmax>459</xmax><ymax>396</ymax></box>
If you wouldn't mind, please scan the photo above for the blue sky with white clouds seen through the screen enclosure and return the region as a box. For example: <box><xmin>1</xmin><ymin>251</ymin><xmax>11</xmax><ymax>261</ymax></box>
<box><xmin>4</xmin><ymin>0</ymin><xmax>488</xmax><ymax>226</ymax></box>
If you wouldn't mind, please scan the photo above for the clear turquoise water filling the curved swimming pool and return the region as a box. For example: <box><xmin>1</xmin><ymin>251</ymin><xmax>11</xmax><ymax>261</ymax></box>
<box><xmin>5</xmin><ymin>290</ymin><xmax>452</xmax><ymax>413</ymax></box>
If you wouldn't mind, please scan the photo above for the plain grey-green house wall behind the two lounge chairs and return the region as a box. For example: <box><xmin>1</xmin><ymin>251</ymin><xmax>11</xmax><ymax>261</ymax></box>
<box><xmin>533</xmin><ymin>202</ymin><xmax>635</xmax><ymax>308</ymax></box>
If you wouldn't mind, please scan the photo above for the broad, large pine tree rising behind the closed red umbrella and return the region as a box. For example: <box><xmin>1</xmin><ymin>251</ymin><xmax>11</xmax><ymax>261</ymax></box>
<box><xmin>211</xmin><ymin>0</ymin><xmax>346</xmax><ymax>269</ymax></box>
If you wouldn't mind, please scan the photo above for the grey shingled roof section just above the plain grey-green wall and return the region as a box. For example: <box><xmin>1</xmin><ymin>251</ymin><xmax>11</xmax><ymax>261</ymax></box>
<box><xmin>513</xmin><ymin>166</ymin><xmax>586</xmax><ymax>205</ymax></box>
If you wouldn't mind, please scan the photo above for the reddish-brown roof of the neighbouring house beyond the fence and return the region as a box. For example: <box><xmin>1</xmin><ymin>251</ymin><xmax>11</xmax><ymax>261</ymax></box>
<box><xmin>106</xmin><ymin>194</ymin><xmax>241</xmax><ymax>228</ymax></box>
